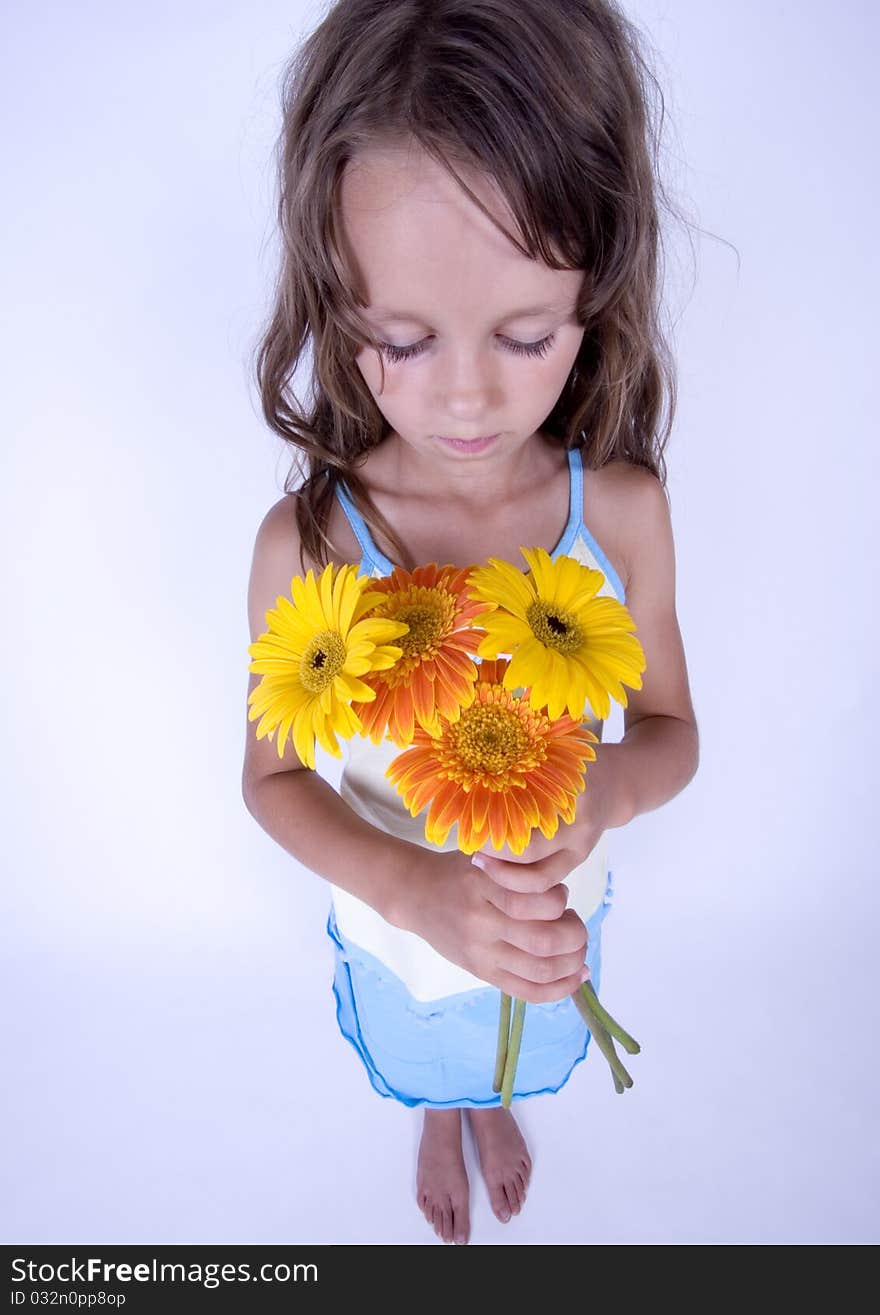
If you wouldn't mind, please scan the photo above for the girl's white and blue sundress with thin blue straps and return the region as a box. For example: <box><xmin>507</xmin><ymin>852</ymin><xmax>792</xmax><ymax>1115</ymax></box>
<box><xmin>326</xmin><ymin>448</ymin><xmax>626</xmax><ymax>1109</ymax></box>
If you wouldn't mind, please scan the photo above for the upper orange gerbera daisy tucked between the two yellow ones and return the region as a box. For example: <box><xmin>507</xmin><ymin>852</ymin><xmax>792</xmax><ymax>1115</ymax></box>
<box><xmin>351</xmin><ymin>562</ymin><xmax>495</xmax><ymax>746</ymax></box>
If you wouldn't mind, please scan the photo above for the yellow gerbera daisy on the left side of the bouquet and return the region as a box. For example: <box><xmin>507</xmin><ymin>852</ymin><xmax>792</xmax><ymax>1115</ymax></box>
<box><xmin>247</xmin><ymin>562</ymin><xmax>408</xmax><ymax>768</ymax></box>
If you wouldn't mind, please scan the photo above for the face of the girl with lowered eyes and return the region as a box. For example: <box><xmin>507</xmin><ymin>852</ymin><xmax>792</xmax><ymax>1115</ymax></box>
<box><xmin>341</xmin><ymin>146</ymin><xmax>584</xmax><ymax>463</ymax></box>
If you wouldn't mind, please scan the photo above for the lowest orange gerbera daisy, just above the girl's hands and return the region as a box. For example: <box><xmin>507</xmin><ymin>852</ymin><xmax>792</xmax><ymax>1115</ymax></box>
<box><xmin>385</xmin><ymin>654</ymin><xmax>599</xmax><ymax>853</ymax></box>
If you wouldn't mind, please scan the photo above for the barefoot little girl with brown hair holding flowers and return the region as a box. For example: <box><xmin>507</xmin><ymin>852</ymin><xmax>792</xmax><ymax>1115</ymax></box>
<box><xmin>242</xmin><ymin>0</ymin><xmax>698</xmax><ymax>1243</ymax></box>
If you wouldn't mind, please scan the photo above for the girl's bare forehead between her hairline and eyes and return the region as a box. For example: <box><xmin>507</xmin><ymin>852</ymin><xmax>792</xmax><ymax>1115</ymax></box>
<box><xmin>339</xmin><ymin>147</ymin><xmax>583</xmax><ymax>323</ymax></box>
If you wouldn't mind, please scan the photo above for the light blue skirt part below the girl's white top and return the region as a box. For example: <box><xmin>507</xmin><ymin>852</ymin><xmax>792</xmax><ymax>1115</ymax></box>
<box><xmin>326</xmin><ymin>872</ymin><xmax>613</xmax><ymax>1109</ymax></box>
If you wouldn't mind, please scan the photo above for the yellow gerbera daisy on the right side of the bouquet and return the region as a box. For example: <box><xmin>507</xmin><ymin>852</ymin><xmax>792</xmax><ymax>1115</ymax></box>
<box><xmin>470</xmin><ymin>548</ymin><xmax>646</xmax><ymax>721</ymax></box>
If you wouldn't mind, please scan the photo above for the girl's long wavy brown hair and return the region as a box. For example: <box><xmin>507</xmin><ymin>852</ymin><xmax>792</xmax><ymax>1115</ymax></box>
<box><xmin>249</xmin><ymin>0</ymin><xmax>676</xmax><ymax>569</ymax></box>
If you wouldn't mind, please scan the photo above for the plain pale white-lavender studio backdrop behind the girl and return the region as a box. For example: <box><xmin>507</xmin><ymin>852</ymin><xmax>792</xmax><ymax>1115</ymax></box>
<box><xmin>0</xmin><ymin>0</ymin><xmax>880</xmax><ymax>1245</ymax></box>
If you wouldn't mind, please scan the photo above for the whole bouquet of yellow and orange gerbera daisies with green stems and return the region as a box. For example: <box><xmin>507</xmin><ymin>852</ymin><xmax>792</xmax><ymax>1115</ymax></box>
<box><xmin>249</xmin><ymin>548</ymin><xmax>646</xmax><ymax>1106</ymax></box>
